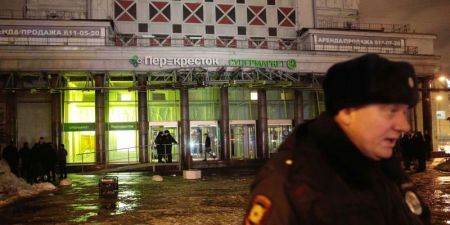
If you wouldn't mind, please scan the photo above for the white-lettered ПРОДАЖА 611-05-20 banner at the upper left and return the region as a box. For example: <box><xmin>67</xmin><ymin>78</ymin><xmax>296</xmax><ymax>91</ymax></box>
<box><xmin>0</xmin><ymin>26</ymin><xmax>102</xmax><ymax>37</ymax></box>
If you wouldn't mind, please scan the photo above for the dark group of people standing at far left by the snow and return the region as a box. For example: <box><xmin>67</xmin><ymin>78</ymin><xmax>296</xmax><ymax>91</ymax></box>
<box><xmin>2</xmin><ymin>137</ymin><xmax>67</xmax><ymax>183</ymax></box>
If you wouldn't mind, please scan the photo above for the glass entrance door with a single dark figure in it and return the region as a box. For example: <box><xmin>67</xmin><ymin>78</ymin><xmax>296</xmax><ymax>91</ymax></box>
<box><xmin>190</xmin><ymin>121</ymin><xmax>219</xmax><ymax>161</ymax></box>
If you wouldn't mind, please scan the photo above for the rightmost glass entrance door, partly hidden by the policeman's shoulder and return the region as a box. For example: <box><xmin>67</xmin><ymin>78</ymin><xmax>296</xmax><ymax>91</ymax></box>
<box><xmin>267</xmin><ymin>120</ymin><xmax>292</xmax><ymax>155</ymax></box>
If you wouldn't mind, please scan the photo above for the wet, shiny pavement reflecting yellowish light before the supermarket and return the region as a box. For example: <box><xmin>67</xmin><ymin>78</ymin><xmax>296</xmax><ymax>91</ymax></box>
<box><xmin>0</xmin><ymin>160</ymin><xmax>450</xmax><ymax>225</ymax></box>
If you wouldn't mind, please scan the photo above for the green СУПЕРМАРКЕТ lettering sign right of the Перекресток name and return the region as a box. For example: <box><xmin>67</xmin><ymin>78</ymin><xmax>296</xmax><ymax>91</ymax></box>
<box><xmin>228</xmin><ymin>59</ymin><xmax>297</xmax><ymax>70</ymax></box>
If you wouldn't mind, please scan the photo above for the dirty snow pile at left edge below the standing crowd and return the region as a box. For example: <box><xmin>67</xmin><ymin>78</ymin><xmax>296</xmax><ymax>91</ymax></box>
<box><xmin>0</xmin><ymin>160</ymin><xmax>56</xmax><ymax>207</ymax></box>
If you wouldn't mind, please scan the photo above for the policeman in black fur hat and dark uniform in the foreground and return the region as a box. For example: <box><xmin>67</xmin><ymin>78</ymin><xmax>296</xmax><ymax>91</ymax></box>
<box><xmin>244</xmin><ymin>54</ymin><xmax>430</xmax><ymax>225</ymax></box>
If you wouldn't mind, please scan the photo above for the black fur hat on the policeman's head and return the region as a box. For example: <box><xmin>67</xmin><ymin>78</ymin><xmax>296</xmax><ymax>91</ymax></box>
<box><xmin>323</xmin><ymin>53</ymin><xmax>418</xmax><ymax>115</ymax></box>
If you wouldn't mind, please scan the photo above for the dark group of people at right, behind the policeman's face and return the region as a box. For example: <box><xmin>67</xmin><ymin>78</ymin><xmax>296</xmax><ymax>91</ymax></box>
<box><xmin>396</xmin><ymin>131</ymin><xmax>431</xmax><ymax>172</ymax></box>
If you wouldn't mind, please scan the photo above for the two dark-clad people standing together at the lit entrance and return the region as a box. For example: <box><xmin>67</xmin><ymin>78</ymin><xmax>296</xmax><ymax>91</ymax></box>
<box><xmin>154</xmin><ymin>130</ymin><xmax>178</xmax><ymax>163</ymax></box>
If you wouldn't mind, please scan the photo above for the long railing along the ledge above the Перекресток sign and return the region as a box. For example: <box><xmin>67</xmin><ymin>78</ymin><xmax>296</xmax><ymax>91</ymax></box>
<box><xmin>0</xmin><ymin>36</ymin><xmax>419</xmax><ymax>55</ymax></box>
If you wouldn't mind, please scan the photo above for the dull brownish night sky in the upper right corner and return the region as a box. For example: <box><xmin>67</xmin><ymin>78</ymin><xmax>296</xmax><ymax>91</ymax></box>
<box><xmin>359</xmin><ymin>0</ymin><xmax>450</xmax><ymax>74</ymax></box>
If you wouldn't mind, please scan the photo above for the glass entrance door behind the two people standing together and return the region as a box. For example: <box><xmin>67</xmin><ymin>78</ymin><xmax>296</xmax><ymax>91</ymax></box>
<box><xmin>149</xmin><ymin>121</ymin><xmax>180</xmax><ymax>163</ymax></box>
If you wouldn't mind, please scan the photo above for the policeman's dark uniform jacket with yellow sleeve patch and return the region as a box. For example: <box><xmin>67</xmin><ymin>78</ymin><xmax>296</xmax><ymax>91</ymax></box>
<box><xmin>244</xmin><ymin>113</ymin><xmax>430</xmax><ymax>225</ymax></box>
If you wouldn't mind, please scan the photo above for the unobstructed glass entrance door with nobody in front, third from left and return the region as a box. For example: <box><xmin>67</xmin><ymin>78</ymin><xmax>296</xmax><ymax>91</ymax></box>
<box><xmin>230</xmin><ymin>120</ymin><xmax>256</xmax><ymax>159</ymax></box>
